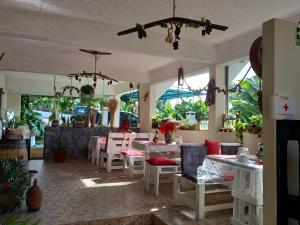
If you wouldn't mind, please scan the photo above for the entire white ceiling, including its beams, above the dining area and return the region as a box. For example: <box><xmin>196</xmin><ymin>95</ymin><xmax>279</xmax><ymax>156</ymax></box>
<box><xmin>0</xmin><ymin>0</ymin><xmax>300</xmax><ymax>82</ymax></box>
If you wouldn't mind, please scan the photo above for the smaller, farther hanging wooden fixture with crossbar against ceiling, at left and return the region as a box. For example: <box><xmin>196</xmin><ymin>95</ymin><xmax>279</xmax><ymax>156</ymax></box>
<box><xmin>68</xmin><ymin>49</ymin><xmax>119</xmax><ymax>89</ymax></box>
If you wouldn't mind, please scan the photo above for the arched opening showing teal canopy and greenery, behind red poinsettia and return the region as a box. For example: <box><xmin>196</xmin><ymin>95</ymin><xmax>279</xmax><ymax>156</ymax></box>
<box><xmin>153</xmin><ymin>72</ymin><xmax>209</xmax><ymax>130</ymax></box>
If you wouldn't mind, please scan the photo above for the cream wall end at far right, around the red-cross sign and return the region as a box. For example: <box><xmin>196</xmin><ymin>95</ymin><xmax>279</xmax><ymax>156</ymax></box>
<box><xmin>263</xmin><ymin>19</ymin><xmax>300</xmax><ymax>225</ymax></box>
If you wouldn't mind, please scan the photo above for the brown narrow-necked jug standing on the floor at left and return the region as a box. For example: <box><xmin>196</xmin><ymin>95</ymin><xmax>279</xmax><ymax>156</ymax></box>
<box><xmin>26</xmin><ymin>179</ymin><xmax>42</xmax><ymax>212</ymax></box>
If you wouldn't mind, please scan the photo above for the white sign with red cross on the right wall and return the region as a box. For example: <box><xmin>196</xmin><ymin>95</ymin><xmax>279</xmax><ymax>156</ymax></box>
<box><xmin>272</xmin><ymin>96</ymin><xmax>296</xmax><ymax>120</ymax></box>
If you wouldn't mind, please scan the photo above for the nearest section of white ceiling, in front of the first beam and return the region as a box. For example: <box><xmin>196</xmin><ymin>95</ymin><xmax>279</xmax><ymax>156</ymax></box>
<box><xmin>0</xmin><ymin>0</ymin><xmax>300</xmax><ymax>43</ymax></box>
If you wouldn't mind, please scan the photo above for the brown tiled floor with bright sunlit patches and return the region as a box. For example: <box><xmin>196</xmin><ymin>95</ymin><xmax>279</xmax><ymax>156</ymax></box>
<box><xmin>17</xmin><ymin>160</ymin><xmax>232</xmax><ymax>225</ymax></box>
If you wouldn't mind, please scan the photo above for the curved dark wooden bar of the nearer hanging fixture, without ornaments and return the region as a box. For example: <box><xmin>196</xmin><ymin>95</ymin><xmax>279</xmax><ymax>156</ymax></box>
<box><xmin>118</xmin><ymin>17</ymin><xmax>228</xmax><ymax>36</ymax></box>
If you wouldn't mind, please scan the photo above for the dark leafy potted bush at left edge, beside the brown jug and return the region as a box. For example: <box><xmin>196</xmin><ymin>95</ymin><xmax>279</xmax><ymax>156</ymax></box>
<box><xmin>0</xmin><ymin>158</ymin><xmax>30</xmax><ymax>213</ymax></box>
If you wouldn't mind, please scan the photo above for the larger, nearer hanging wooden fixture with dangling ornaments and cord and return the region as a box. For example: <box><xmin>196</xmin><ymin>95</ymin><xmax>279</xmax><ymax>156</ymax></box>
<box><xmin>118</xmin><ymin>0</ymin><xmax>228</xmax><ymax>50</ymax></box>
